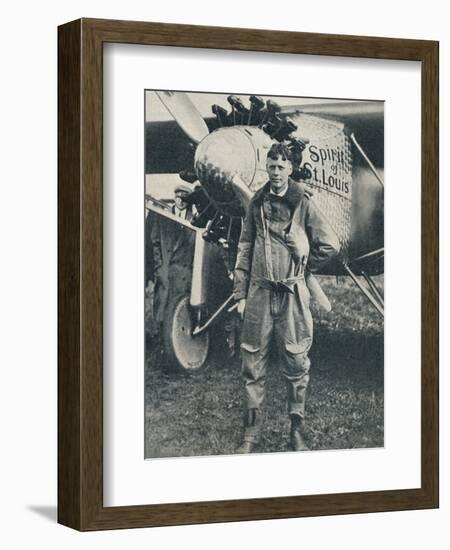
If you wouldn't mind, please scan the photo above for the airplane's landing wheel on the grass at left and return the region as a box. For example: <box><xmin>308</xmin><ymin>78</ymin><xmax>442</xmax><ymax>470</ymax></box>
<box><xmin>164</xmin><ymin>295</ymin><xmax>209</xmax><ymax>374</ymax></box>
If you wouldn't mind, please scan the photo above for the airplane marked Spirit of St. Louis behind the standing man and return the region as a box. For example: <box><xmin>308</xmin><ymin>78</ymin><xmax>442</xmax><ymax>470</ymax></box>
<box><xmin>145</xmin><ymin>91</ymin><xmax>384</xmax><ymax>373</ymax></box>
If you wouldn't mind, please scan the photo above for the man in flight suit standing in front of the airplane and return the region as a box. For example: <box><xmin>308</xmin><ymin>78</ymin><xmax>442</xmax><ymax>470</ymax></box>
<box><xmin>234</xmin><ymin>143</ymin><xmax>339</xmax><ymax>453</ymax></box>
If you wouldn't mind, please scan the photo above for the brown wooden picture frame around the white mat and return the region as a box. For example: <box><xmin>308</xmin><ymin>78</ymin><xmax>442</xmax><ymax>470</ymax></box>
<box><xmin>58</xmin><ymin>19</ymin><xmax>439</xmax><ymax>531</ymax></box>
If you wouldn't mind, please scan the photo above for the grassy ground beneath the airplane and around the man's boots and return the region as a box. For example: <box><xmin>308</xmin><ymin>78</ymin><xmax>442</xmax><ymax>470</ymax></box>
<box><xmin>145</xmin><ymin>276</ymin><xmax>384</xmax><ymax>458</ymax></box>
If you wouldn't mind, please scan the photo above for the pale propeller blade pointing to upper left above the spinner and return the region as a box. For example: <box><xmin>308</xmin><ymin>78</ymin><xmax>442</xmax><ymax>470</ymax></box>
<box><xmin>156</xmin><ymin>92</ymin><xmax>209</xmax><ymax>144</ymax></box>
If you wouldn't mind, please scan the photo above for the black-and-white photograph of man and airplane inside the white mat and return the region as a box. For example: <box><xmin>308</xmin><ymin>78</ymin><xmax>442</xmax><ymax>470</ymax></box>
<box><xmin>143</xmin><ymin>90</ymin><xmax>385</xmax><ymax>459</ymax></box>
